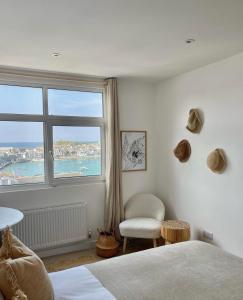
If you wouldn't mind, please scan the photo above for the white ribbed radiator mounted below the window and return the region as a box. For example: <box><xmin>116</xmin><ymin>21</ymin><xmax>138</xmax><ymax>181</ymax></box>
<box><xmin>13</xmin><ymin>203</ymin><xmax>87</xmax><ymax>250</ymax></box>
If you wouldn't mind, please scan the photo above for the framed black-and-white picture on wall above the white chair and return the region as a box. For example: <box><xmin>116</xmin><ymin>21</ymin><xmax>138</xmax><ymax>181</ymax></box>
<box><xmin>121</xmin><ymin>130</ymin><xmax>147</xmax><ymax>172</ymax></box>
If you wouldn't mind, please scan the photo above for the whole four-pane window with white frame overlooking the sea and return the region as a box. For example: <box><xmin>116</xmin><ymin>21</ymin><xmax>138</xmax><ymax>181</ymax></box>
<box><xmin>0</xmin><ymin>84</ymin><xmax>104</xmax><ymax>188</ymax></box>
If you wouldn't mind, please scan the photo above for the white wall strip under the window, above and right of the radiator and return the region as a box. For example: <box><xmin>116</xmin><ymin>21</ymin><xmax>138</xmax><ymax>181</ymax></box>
<box><xmin>0</xmin><ymin>183</ymin><xmax>105</xmax><ymax>241</ymax></box>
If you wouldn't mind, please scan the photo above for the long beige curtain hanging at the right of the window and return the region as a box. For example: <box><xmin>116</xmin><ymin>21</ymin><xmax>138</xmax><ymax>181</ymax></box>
<box><xmin>105</xmin><ymin>78</ymin><xmax>124</xmax><ymax>238</ymax></box>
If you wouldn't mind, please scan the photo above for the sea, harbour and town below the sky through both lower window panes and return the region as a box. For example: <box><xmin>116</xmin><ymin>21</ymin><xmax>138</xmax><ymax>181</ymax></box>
<box><xmin>0</xmin><ymin>140</ymin><xmax>101</xmax><ymax>185</ymax></box>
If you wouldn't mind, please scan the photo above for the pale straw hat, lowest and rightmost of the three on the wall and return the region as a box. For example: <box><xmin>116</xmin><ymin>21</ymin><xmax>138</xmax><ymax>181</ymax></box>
<box><xmin>207</xmin><ymin>149</ymin><xmax>226</xmax><ymax>173</ymax></box>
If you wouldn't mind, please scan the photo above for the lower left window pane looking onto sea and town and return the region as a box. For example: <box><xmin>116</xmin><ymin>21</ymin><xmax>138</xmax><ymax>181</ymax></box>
<box><xmin>0</xmin><ymin>121</ymin><xmax>45</xmax><ymax>185</ymax></box>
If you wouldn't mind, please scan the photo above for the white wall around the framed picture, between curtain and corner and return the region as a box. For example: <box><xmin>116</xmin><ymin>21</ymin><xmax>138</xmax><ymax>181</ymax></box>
<box><xmin>118</xmin><ymin>79</ymin><xmax>155</xmax><ymax>202</ymax></box>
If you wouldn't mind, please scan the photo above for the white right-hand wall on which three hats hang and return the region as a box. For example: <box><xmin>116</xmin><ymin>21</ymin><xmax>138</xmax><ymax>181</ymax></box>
<box><xmin>155</xmin><ymin>54</ymin><xmax>243</xmax><ymax>257</ymax></box>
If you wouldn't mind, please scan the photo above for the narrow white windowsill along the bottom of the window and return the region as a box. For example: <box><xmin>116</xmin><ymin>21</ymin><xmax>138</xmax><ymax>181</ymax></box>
<box><xmin>0</xmin><ymin>176</ymin><xmax>105</xmax><ymax>194</ymax></box>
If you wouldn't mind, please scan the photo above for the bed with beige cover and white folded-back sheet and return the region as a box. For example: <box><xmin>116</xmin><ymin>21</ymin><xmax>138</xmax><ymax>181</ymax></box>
<box><xmin>49</xmin><ymin>241</ymin><xmax>243</xmax><ymax>300</ymax></box>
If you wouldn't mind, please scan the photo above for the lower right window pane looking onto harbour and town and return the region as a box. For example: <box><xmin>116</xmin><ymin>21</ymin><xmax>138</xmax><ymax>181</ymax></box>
<box><xmin>53</xmin><ymin>126</ymin><xmax>101</xmax><ymax>178</ymax></box>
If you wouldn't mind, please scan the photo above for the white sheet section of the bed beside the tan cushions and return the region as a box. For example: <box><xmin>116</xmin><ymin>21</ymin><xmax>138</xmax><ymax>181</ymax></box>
<box><xmin>49</xmin><ymin>266</ymin><xmax>115</xmax><ymax>300</ymax></box>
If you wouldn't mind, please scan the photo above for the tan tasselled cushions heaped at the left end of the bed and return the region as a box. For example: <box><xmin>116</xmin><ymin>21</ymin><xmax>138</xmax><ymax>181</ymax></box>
<box><xmin>0</xmin><ymin>230</ymin><xmax>54</xmax><ymax>300</ymax></box>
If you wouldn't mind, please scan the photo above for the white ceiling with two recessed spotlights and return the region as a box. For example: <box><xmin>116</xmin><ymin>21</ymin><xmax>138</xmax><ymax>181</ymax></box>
<box><xmin>0</xmin><ymin>0</ymin><xmax>243</xmax><ymax>80</ymax></box>
